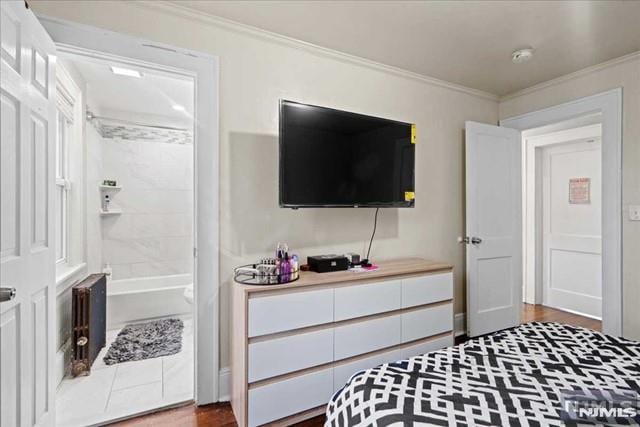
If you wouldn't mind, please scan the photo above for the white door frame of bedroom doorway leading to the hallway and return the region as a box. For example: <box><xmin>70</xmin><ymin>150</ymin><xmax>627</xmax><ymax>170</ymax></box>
<box><xmin>500</xmin><ymin>88</ymin><xmax>622</xmax><ymax>336</ymax></box>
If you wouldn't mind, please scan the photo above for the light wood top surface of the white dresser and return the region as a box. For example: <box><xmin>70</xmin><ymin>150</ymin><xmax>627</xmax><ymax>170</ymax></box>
<box><xmin>234</xmin><ymin>258</ymin><xmax>453</xmax><ymax>293</ymax></box>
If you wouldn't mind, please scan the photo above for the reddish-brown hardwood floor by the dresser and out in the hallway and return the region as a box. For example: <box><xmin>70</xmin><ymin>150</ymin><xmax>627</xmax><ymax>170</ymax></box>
<box><xmin>113</xmin><ymin>304</ymin><xmax>602</xmax><ymax>427</ymax></box>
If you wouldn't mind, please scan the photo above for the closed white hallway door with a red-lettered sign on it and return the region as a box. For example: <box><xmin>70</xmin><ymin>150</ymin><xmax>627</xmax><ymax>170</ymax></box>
<box><xmin>542</xmin><ymin>140</ymin><xmax>602</xmax><ymax>318</ymax></box>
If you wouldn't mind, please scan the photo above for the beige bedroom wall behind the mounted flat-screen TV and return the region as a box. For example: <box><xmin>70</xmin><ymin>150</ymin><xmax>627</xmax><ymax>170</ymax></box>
<box><xmin>32</xmin><ymin>1</ymin><xmax>498</xmax><ymax>367</ymax></box>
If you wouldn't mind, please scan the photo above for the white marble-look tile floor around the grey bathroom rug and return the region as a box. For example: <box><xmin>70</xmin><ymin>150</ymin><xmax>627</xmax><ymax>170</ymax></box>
<box><xmin>56</xmin><ymin>318</ymin><xmax>193</xmax><ymax>427</ymax></box>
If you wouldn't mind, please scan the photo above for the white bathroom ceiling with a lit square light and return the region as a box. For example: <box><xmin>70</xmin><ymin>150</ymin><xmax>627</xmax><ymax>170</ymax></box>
<box><xmin>65</xmin><ymin>56</ymin><xmax>194</xmax><ymax>128</ymax></box>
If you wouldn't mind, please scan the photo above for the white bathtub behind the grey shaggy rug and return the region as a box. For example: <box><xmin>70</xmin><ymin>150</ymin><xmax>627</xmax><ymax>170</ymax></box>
<box><xmin>107</xmin><ymin>274</ymin><xmax>193</xmax><ymax>329</ymax></box>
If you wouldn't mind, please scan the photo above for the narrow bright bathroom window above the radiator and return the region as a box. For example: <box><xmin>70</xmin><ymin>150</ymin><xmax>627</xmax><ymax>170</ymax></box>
<box><xmin>55</xmin><ymin>109</ymin><xmax>71</xmax><ymax>263</ymax></box>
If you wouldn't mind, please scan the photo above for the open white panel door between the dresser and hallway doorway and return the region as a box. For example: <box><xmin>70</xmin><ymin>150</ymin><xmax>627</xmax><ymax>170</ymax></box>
<box><xmin>466</xmin><ymin>122</ymin><xmax>522</xmax><ymax>337</ymax></box>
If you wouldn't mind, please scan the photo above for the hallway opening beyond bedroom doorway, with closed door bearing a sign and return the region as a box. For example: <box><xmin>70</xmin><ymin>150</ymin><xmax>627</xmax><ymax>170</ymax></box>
<box><xmin>523</xmin><ymin>122</ymin><xmax>602</xmax><ymax>320</ymax></box>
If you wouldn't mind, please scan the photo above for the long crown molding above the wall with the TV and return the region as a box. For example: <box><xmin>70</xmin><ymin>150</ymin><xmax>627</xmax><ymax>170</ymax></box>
<box><xmin>134</xmin><ymin>0</ymin><xmax>500</xmax><ymax>102</ymax></box>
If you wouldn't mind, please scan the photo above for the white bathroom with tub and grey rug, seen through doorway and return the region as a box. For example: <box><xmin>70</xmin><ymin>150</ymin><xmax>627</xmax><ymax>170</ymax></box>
<box><xmin>55</xmin><ymin>52</ymin><xmax>194</xmax><ymax>426</ymax></box>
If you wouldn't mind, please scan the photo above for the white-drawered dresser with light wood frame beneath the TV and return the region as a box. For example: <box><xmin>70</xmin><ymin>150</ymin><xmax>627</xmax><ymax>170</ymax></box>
<box><xmin>231</xmin><ymin>258</ymin><xmax>453</xmax><ymax>426</ymax></box>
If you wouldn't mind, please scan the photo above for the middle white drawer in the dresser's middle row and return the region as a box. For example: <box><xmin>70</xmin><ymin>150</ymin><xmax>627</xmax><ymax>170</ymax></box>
<box><xmin>334</xmin><ymin>314</ymin><xmax>400</xmax><ymax>360</ymax></box>
